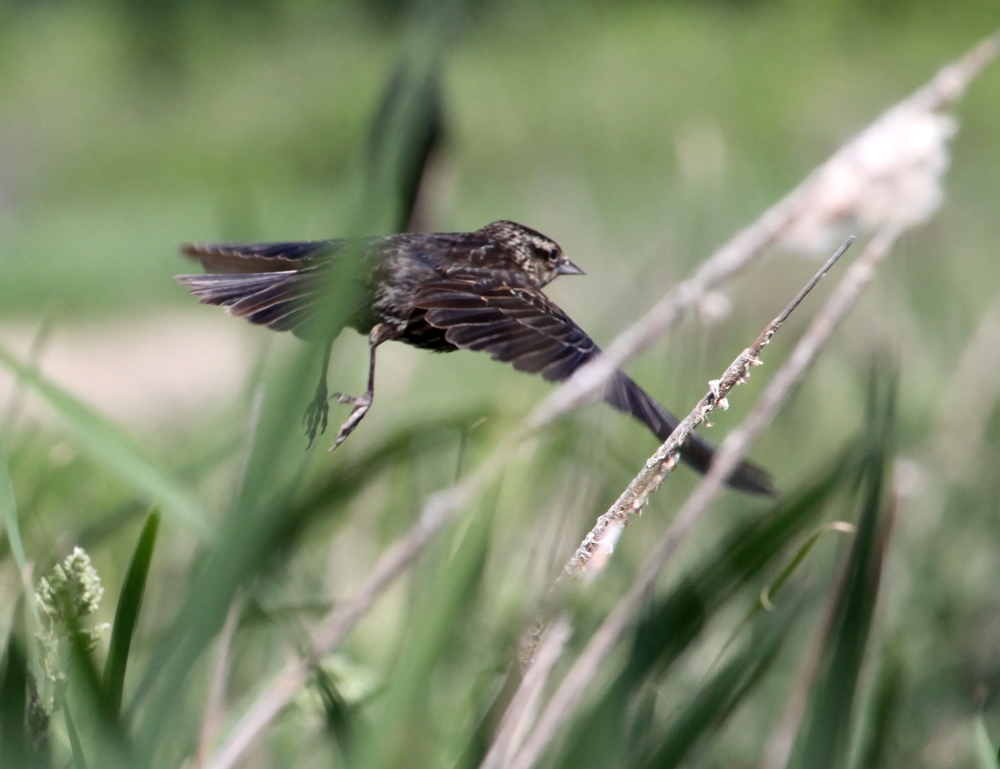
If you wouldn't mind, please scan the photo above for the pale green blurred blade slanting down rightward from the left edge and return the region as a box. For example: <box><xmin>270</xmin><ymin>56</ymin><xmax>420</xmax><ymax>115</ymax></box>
<box><xmin>0</xmin><ymin>347</ymin><xmax>211</xmax><ymax>539</ymax></box>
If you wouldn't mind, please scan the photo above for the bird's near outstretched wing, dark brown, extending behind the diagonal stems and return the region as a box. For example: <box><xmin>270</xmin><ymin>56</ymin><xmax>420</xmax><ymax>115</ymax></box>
<box><xmin>414</xmin><ymin>277</ymin><xmax>774</xmax><ymax>494</ymax></box>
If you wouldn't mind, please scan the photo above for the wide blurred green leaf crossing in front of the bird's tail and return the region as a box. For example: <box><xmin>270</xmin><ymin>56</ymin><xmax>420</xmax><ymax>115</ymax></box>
<box><xmin>130</xmin><ymin>37</ymin><xmax>468</xmax><ymax>754</ymax></box>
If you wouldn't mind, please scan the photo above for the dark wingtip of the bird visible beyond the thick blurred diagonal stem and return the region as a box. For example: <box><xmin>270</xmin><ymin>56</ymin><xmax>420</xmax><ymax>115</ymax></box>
<box><xmin>604</xmin><ymin>371</ymin><xmax>775</xmax><ymax>495</ymax></box>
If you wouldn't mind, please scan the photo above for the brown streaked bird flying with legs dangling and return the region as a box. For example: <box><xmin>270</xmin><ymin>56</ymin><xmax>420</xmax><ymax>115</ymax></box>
<box><xmin>177</xmin><ymin>221</ymin><xmax>774</xmax><ymax>494</ymax></box>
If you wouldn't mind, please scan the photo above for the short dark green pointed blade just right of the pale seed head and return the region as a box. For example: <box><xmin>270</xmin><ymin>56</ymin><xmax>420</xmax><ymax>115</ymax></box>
<box><xmin>104</xmin><ymin>511</ymin><xmax>160</xmax><ymax>718</ymax></box>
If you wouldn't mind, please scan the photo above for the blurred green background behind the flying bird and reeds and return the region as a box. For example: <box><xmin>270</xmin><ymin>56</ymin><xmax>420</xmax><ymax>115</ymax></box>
<box><xmin>0</xmin><ymin>0</ymin><xmax>1000</xmax><ymax>767</ymax></box>
